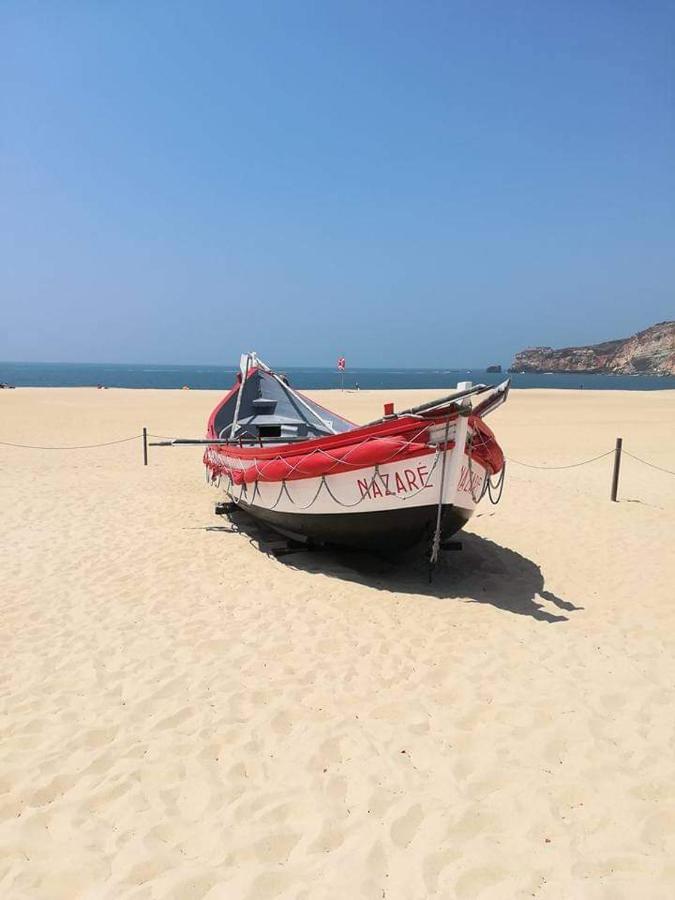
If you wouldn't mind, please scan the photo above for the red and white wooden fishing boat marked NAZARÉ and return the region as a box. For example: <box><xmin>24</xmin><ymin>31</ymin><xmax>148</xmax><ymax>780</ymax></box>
<box><xmin>204</xmin><ymin>352</ymin><xmax>509</xmax><ymax>560</ymax></box>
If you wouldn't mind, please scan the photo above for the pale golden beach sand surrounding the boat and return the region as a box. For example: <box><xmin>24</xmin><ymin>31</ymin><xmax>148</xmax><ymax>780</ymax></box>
<box><xmin>0</xmin><ymin>389</ymin><xmax>675</xmax><ymax>900</ymax></box>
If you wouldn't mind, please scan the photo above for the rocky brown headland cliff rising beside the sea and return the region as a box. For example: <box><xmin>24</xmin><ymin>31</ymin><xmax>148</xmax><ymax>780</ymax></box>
<box><xmin>509</xmin><ymin>322</ymin><xmax>675</xmax><ymax>375</ymax></box>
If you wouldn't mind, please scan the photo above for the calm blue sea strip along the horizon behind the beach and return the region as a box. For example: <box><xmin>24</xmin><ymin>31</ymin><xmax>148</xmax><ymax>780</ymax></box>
<box><xmin>0</xmin><ymin>362</ymin><xmax>675</xmax><ymax>391</ymax></box>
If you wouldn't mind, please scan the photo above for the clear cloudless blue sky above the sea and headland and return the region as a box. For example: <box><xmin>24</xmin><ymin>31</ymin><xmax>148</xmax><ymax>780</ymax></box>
<box><xmin>0</xmin><ymin>0</ymin><xmax>675</xmax><ymax>367</ymax></box>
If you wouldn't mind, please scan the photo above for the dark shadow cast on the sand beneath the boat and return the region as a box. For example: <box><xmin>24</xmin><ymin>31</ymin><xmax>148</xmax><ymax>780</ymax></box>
<box><xmin>227</xmin><ymin>514</ymin><xmax>583</xmax><ymax>623</ymax></box>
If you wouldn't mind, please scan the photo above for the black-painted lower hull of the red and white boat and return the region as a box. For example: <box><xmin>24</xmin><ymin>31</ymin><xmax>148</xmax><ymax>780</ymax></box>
<box><xmin>230</xmin><ymin>501</ymin><xmax>473</xmax><ymax>552</ymax></box>
